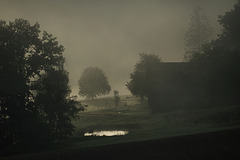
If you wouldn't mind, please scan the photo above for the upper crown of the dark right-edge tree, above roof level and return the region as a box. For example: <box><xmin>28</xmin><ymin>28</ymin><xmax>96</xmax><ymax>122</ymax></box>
<box><xmin>190</xmin><ymin>0</ymin><xmax>240</xmax><ymax>64</ymax></box>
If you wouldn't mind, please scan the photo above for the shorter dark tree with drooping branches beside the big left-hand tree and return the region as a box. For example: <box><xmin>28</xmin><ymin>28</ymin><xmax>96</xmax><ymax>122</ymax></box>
<box><xmin>35</xmin><ymin>69</ymin><xmax>79</xmax><ymax>142</ymax></box>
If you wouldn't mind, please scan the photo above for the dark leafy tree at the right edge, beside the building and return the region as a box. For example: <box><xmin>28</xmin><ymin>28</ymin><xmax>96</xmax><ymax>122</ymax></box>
<box><xmin>191</xmin><ymin>0</ymin><xmax>240</xmax><ymax>104</ymax></box>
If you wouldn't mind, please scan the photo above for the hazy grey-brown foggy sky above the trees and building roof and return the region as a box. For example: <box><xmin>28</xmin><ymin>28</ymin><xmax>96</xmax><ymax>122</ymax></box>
<box><xmin>0</xmin><ymin>0</ymin><xmax>236</xmax><ymax>95</ymax></box>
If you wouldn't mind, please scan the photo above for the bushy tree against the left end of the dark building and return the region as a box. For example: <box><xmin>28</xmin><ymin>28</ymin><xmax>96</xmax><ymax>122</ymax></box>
<box><xmin>126</xmin><ymin>53</ymin><xmax>161</xmax><ymax>99</ymax></box>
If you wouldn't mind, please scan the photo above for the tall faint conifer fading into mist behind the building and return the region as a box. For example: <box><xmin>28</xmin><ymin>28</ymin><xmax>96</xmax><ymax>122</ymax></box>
<box><xmin>183</xmin><ymin>6</ymin><xmax>213</xmax><ymax>61</ymax></box>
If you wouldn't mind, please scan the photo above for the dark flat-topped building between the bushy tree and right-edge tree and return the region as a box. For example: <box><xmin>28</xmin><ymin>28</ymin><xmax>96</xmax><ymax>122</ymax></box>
<box><xmin>149</xmin><ymin>63</ymin><xmax>238</xmax><ymax>113</ymax></box>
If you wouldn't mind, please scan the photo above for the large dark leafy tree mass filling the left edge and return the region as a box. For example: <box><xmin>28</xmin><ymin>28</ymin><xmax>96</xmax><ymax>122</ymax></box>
<box><xmin>0</xmin><ymin>19</ymin><xmax>77</xmax><ymax>150</ymax></box>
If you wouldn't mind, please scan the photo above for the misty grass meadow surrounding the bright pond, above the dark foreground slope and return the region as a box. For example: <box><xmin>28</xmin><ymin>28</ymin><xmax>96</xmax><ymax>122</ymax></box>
<box><xmin>1</xmin><ymin>96</ymin><xmax>240</xmax><ymax>159</ymax></box>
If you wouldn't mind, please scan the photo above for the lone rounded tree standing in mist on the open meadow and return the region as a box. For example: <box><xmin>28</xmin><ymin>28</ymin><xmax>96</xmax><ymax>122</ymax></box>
<box><xmin>78</xmin><ymin>67</ymin><xmax>111</xmax><ymax>99</ymax></box>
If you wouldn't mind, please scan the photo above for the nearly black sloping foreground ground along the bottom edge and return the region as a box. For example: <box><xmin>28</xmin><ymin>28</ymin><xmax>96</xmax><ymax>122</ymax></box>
<box><xmin>3</xmin><ymin>129</ymin><xmax>240</xmax><ymax>160</ymax></box>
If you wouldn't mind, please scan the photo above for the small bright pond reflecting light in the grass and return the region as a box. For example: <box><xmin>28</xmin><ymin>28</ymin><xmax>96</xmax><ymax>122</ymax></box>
<box><xmin>84</xmin><ymin>131</ymin><xmax>129</xmax><ymax>136</ymax></box>
